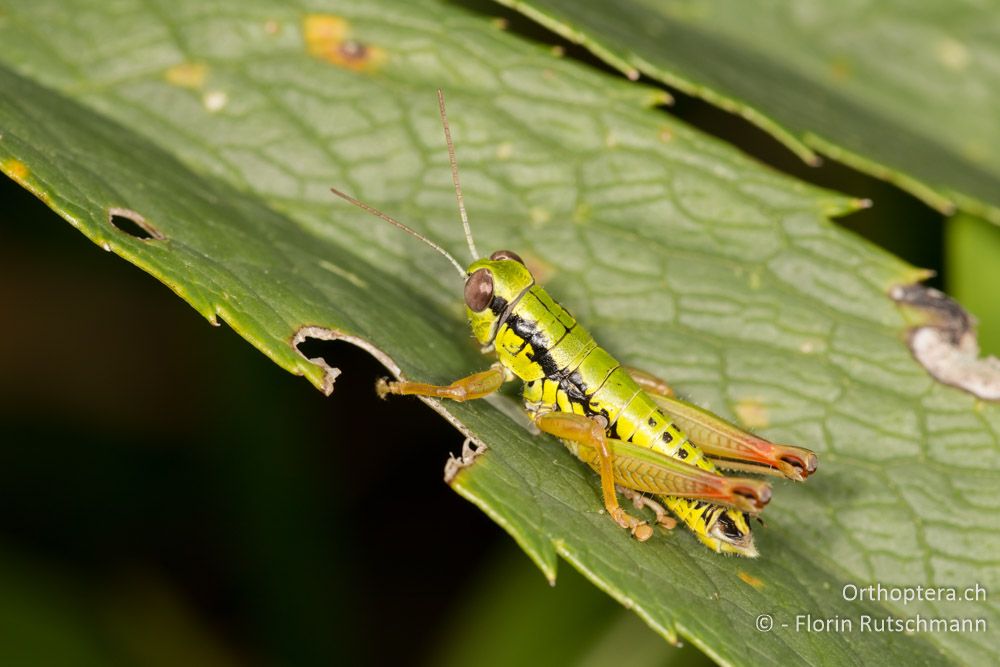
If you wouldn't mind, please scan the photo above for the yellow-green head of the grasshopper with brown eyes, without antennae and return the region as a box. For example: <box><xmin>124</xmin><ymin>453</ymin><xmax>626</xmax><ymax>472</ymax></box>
<box><xmin>465</xmin><ymin>250</ymin><xmax>535</xmax><ymax>345</ymax></box>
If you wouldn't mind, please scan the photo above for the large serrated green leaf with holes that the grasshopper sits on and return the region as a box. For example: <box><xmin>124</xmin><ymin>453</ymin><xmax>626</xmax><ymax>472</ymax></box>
<box><xmin>0</xmin><ymin>0</ymin><xmax>1000</xmax><ymax>664</ymax></box>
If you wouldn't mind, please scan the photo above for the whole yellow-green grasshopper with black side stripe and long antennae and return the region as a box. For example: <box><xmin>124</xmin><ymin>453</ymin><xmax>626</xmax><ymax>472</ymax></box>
<box><xmin>332</xmin><ymin>91</ymin><xmax>817</xmax><ymax>558</ymax></box>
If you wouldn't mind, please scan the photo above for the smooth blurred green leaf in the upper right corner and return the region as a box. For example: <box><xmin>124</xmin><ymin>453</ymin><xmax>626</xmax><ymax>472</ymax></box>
<box><xmin>497</xmin><ymin>0</ymin><xmax>1000</xmax><ymax>224</ymax></box>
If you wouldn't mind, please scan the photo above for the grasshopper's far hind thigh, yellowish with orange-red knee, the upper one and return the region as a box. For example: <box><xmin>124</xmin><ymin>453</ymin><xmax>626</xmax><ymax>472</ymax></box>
<box><xmin>628</xmin><ymin>368</ymin><xmax>818</xmax><ymax>482</ymax></box>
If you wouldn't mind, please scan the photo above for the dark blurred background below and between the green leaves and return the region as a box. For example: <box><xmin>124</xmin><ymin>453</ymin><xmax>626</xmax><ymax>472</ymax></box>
<box><xmin>0</xmin><ymin>7</ymin><xmax>1000</xmax><ymax>667</ymax></box>
